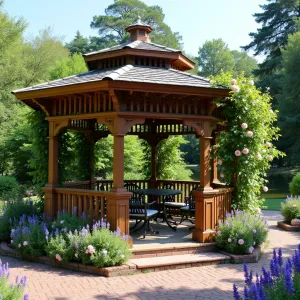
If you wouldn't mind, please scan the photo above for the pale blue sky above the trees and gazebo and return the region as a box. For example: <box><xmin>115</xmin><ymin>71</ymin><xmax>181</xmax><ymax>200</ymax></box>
<box><xmin>4</xmin><ymin>0</ymin><xmax>266</xmax><ymax>60</ymax></box>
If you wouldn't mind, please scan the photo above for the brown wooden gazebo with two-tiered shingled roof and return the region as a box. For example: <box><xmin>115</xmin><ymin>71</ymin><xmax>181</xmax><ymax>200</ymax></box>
<box><xmin>14</xmin><ymin>18</ymin><xmax>232</xmax><ymax>242</ymax></box>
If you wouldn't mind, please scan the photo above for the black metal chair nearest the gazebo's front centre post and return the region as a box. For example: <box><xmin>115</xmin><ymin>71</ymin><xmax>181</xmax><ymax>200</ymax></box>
<box><xmin>129</xmin><ymin>193</ymin><xmax>159</xmax><ymax>238</ymax></box>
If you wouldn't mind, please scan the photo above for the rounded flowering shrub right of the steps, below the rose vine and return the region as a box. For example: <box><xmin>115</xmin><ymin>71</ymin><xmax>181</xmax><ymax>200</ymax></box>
<box><xmin>216</xmin><ymin>210</ymin><xmax>268</xmax><ymax>254</ymax></box>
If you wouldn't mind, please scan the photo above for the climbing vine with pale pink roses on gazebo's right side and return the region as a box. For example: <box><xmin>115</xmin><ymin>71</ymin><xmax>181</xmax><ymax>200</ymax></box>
<box><xmin>212</xmin><ymin>73</ymin><xmax>284</xmax><ymax>210</ymax></box>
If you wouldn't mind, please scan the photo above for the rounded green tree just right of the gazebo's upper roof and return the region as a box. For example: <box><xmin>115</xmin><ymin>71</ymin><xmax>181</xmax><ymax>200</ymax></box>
<box><xmin>198</xmin><ymin>39</ymin><xmax>234</xmax><ymax>77</ymax></box>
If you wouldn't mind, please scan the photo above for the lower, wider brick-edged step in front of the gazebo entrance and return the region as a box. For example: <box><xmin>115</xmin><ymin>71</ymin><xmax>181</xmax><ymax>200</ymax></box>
<box><xmin>130</xmin><ymin>252</ymin><xmax>230</xmax><ymax>271</ymax></box>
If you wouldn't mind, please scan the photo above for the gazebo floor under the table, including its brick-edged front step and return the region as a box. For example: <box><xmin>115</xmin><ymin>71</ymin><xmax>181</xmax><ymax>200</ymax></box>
<box><xmin>130</xmin><ymin>219</ymin><xmax>215</xmax><ymax>256</ymax></box>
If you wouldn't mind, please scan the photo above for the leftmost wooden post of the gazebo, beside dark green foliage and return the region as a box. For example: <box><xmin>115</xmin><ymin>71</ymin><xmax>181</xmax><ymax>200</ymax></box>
<box><xmin>43</xmin><ymin>122</ymin><xmax>58</xmax><ymax>219</ymax></box>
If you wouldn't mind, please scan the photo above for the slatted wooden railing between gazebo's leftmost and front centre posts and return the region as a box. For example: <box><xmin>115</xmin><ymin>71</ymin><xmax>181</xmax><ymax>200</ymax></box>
<box><xmin>55</xmin><ymin>188</ymin><xmax>107</xmax><ymax>224</ymax></box>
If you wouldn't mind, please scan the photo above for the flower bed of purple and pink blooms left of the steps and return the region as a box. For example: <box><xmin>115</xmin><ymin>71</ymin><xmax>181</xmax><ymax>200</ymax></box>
<box><xmin>7</xmin><ymin>212</ymin><xmax>131</xmax><ymax>268</ymax></box>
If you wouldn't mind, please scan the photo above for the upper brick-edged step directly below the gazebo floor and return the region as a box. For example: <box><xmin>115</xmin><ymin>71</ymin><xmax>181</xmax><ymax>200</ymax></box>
<box><xmin>132</xmin><ymin>242</ymin><xmax>216</xmax><ymax>259</ymax></box>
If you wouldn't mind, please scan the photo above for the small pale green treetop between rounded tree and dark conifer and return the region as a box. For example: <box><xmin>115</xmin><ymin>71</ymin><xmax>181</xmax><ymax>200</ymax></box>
<box><xmin>231</xmin><ymin>50</ymin><xmax>257</xmax><ymax>77</ymax></box>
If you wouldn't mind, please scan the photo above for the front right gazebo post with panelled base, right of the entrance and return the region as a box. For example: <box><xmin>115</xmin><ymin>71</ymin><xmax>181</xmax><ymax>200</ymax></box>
<box><xmin>193</xmin><ymin>126</ymin><xmax>215</xmax><ymax>243</ymax></box>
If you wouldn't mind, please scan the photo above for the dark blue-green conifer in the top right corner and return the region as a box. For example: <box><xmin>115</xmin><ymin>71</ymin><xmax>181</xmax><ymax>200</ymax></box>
<box><xmin>242</xmin><ymin>0</ymin><xmax>300</xmax><ymax>75</ymax></box>
